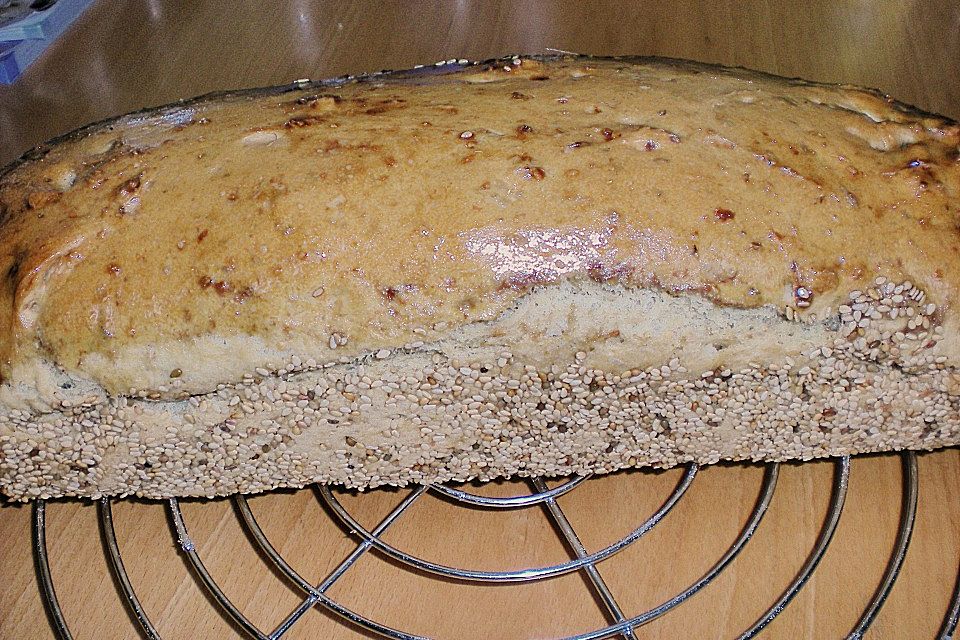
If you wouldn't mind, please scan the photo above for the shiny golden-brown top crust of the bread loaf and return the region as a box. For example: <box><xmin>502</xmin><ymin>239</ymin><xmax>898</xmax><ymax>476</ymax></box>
<box><xmin>0</xmin><ymin>56</ymin><xmax>960</xmax><ymax>408</ymax></box>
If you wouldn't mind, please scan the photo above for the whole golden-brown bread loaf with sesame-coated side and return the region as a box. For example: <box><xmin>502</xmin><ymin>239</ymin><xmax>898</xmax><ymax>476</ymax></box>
<box><xmin>0</xmin><ymin>56</ymin><xmax>960</xmax><ymax>500</ymax></box>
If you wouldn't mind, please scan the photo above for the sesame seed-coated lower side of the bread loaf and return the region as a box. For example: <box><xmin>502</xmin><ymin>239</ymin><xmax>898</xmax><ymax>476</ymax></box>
<box><xmin>0</xmin><ymin>283</ymin><xmax>960</xmax><ymax>500</ymax></box>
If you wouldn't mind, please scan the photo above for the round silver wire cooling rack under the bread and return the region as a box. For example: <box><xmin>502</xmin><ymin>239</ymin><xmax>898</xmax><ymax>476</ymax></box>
<box><xmin>33</xmin><ymin>452</ymin><xmax>960</xmax><ymax>640</ymax></box>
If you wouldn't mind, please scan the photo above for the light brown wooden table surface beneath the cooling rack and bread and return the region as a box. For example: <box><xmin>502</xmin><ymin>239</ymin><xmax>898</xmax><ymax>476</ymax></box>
<box><xmin>0</xmin><ymin>0</ymin><xmax>960</xmax><ymax>640</ymax></box>
